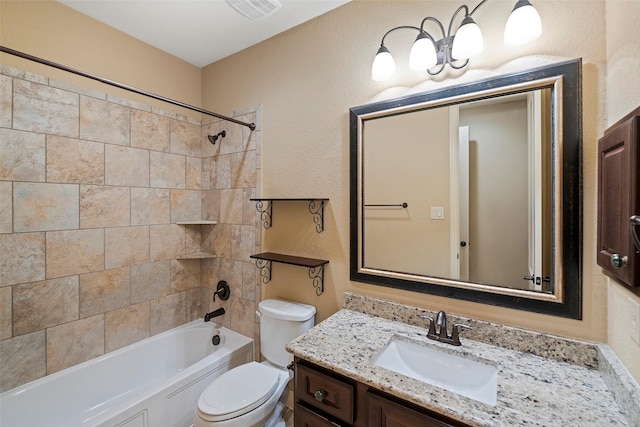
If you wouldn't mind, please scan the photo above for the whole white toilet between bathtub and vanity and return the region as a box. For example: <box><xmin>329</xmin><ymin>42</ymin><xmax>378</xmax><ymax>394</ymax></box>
<box><xmin>193</xmin><ymin>299</ymin><xmax>316</xmax><ymax>427</ymax></box>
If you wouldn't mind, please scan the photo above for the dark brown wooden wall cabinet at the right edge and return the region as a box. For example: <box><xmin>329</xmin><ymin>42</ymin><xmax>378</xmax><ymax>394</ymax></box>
<box><xmin>597</xmin><ymin>107</ymin><xmax>640</xmax><ymax>294</ymax></box>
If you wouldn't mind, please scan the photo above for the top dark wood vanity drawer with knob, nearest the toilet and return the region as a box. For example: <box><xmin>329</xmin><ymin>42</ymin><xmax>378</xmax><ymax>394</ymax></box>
<box><xmin>295</xmin><ymin>363</ymin><xmax>354</xmax><ymax>425</ymax></box>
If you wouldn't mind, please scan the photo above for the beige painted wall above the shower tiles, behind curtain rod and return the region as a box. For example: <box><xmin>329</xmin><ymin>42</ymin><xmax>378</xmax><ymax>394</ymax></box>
<box><xmin>0</xmin><ymin>0</ymin><xmax>202</xmax><ymax>119</ymax></box>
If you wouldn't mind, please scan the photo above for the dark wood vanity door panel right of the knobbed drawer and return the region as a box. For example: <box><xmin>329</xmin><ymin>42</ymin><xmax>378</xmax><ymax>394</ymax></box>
<box><xmin>366</xmin><ymin>392</ymin><xmax>462</xmax><ymax>427</ymax></box>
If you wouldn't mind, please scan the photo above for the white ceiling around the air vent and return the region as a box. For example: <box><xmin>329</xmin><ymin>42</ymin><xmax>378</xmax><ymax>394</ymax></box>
<box><xmin>58</xmin><ymin>0</ymin><xmax>351</xmax><ymax>67</ymax></box>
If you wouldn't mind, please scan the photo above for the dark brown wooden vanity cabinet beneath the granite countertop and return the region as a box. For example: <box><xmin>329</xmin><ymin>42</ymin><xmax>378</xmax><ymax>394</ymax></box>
<box><xmin>294</xmin><ymin>357</ymin><xmax>467</xmax><ymax>427</ymax></box>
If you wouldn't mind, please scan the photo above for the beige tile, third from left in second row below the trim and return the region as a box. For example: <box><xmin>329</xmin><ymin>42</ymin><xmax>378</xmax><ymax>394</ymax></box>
<box><xmin>104</xmin><ymin>144</ymin><xmax>149</xmax><ymax>187</ymax></box>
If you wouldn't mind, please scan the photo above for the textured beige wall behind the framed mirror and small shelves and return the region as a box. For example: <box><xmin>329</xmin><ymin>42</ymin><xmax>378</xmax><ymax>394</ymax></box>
<box><xmin>203</xmin><ymin>0</ymin><xmax>607</xmax><ymax>360</ymax></box>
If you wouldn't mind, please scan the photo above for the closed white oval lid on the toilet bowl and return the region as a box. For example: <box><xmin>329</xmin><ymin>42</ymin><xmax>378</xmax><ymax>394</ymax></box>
<box><xmin>198</xmin><ymin>362</ymin><xmax>279</xmax><ymax>421</ymax></box>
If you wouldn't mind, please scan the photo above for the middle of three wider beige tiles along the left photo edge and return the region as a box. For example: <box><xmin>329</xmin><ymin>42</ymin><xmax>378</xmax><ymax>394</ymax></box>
<box><xmin>0</xmin><ymin>233</ymin><xmax>45</xmax><ymax>286</ymax></box>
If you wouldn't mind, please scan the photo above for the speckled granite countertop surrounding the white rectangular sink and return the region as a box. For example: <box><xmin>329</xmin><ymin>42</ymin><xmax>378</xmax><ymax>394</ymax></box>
<box><xmin>287</xmin><ymin>304</ymin><xmax>640</xmax><ymax>427</ymax></box>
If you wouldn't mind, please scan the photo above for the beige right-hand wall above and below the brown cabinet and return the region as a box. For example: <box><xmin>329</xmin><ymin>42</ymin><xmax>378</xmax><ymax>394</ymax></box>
<box><xmin>606</xmin><ymin>0</ymin><xmax>640</xmax><ymax>381</ymax></box>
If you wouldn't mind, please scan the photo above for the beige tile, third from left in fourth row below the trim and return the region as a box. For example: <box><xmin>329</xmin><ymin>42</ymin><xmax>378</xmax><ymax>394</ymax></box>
<box><xmin>104</xmin><ymin>226</ymin><xmax>149</xmax><ymax>268</ymax></box>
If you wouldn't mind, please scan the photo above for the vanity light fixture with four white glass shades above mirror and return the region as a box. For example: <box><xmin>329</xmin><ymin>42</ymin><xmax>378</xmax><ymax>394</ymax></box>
<box><xmin>371</xmin><ymin>0</ymin><xmax>542</xmax><ymax>81</ymax></box>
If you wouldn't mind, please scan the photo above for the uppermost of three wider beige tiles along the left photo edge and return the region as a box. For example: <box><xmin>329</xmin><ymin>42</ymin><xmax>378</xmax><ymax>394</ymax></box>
<box><xmin>0</xmin><ymin>129</ymin><xmax>46</xmax><ymax>182</ymax></box>
